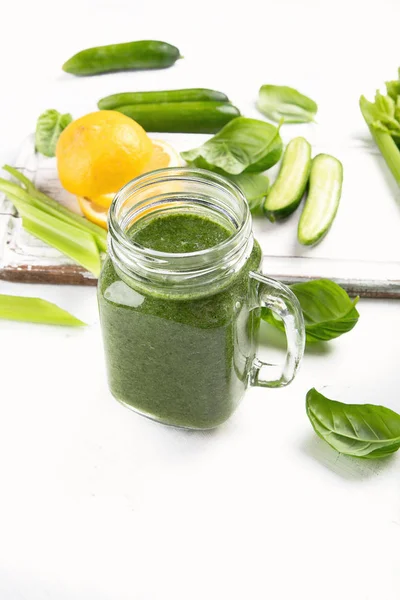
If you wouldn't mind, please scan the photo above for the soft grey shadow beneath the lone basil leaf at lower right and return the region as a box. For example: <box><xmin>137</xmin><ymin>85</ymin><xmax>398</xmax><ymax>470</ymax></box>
<box><xmin>300</xmin><ymin>434</ymin><xmax>395</xmax><ymax>481</ymax></box>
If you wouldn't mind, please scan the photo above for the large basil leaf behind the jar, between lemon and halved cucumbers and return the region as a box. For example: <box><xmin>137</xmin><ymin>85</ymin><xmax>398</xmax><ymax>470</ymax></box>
<box><xmin>181</xmin><ymin>117</ymin><xmax>282</xmax><ymax>175</ymax></box>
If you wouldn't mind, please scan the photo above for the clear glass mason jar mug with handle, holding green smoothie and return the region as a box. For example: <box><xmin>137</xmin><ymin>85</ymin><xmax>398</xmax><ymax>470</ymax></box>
<box><xmin>98</xmin><ymin>168</ymin><xmax>305</xmax><ymax>429</ymax></box>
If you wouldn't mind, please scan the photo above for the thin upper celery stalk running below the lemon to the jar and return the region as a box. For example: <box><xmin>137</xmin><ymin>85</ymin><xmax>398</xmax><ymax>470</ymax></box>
<box><xmin>0</xmin><ymin>165</ymin><xmax>107</xmax><ymax>252</ymax></box>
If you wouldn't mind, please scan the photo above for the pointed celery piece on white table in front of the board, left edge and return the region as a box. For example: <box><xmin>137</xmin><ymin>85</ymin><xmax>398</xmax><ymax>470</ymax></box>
<box><xmin>0</xmin><ymin>294</ymin><xmax>86</xmax><ymax>327</ymax></box>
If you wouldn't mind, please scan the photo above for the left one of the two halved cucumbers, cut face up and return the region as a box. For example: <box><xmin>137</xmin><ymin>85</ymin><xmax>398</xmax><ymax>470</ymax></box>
<box><xmin>264</xmin><ymin>137</ymin><xmax>311</xmax><ymax>221</ymax></box>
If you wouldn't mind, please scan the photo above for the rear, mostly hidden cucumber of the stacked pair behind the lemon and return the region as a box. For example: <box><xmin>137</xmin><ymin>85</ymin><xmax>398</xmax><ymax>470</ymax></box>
<box><xmin>97</xmin><ymin>88</ymin><xmax>229</xmax><ymax>110</ymax></box>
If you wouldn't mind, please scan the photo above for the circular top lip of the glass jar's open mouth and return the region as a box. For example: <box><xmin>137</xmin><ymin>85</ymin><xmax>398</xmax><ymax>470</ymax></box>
<box><xmin>108</xmin><ymin>167</ymin><xmax>250</xmax><ymax>260</ymax></box>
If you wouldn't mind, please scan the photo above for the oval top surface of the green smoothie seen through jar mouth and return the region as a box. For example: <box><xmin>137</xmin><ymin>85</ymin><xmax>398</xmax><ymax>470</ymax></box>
<box><xmin>128</xmin><ymin>213</ymin><xmax>233</xmax><ymax>254</ymax></box>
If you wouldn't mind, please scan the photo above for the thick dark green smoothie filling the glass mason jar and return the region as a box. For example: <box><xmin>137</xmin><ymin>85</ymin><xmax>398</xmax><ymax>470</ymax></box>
<box><xmin>98</xmin><ymin>213</ymin><xmax>261</xmax><ymax>429</ymax></box>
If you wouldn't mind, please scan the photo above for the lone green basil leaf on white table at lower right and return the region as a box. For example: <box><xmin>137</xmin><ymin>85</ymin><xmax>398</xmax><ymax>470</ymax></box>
<box><xmin>306</xmin><ymin>388</ymin><xmax>400</xmax><ymax>458</ymax></box>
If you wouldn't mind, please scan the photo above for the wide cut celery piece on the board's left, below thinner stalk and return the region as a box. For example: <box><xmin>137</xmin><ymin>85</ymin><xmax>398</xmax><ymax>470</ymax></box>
<box><xmin>8</xmin><ymin>194</ymin><xmax>101</xmax><ymax>277</ymax></box>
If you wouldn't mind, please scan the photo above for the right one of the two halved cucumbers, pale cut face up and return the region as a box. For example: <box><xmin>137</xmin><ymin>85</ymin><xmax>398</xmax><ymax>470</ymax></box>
<box><xmin>297</xmin><ymin>154</ymin><xmax>343</xmax><ymax>246</ymax></box>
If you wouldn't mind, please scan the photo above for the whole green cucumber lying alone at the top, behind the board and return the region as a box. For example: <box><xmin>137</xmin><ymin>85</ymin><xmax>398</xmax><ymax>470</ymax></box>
<box><xmin>63</xmin><ymin>40</ymin><xmax>181</xmax><ymax>75</ymax></box>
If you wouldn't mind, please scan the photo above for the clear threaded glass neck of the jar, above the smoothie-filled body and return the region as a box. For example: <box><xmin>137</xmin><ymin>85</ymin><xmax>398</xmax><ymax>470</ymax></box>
<box><xmin>108</xmin><ymin>167</ymin><xmax>253</xmax><ymax>297</ymax></box>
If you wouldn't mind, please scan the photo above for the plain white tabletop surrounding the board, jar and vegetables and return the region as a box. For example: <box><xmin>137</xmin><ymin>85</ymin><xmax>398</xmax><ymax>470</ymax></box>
<box><xmin>0</xmin><ymin>0</ymin><xmax>400</xmax><ymax>600</ymax></box>
